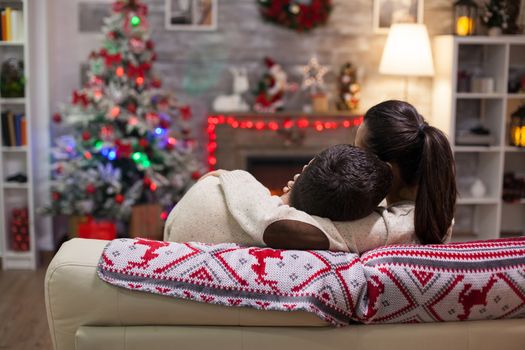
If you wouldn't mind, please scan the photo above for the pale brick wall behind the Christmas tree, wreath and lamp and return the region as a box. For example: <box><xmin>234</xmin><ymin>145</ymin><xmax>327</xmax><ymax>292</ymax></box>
<box><xmin>49</xmin><ymin>0</ymin><xmax>453</xmax><ymax>146</ymax></box>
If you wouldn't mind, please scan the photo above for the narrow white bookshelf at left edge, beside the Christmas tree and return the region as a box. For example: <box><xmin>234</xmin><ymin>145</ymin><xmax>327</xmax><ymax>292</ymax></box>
<box><xmin>0</xmin><ymin>0</ymin><xmax>37</xmax><ymax>269</ymax></box>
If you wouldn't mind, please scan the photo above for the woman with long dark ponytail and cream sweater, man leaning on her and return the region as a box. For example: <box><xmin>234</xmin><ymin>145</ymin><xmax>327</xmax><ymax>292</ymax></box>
<box><xmin>270</xmin><ymin>100</ymin><xmax>457</xmax><ymax>253</ymax></box>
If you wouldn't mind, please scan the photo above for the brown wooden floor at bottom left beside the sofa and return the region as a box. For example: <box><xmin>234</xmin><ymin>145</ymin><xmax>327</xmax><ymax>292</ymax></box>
<box><xmin>0</xmin><ymin>259</ymin><xmax>53</xmax><ymax>350</ymax></box>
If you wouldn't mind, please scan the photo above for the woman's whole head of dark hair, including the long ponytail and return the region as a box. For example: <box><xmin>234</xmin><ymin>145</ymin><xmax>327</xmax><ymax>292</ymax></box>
<box><xmin>364</xmin><ymin>100</ymin><xmax>457</xmax><ymax>244</ymax></box>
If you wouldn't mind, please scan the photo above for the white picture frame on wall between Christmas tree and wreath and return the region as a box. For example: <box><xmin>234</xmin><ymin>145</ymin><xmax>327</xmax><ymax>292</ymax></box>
<box><xmin>165</xmin><ymin>0</ymin><xmax>219</xmax><ymax>31</ymax></box>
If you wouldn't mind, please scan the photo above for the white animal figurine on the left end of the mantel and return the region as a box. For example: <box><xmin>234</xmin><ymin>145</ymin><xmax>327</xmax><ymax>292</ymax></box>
<box><xmin>213</xmin><ymin>67</ymin><xmax>250</xmax><ymax>112</ymax></box>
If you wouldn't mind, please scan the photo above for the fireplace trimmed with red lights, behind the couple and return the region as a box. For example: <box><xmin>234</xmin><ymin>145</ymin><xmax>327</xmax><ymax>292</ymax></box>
<box><xmin>207</xmin><ymin>113</ymin><xmax>362</xmax><ymax>195</ymax></box>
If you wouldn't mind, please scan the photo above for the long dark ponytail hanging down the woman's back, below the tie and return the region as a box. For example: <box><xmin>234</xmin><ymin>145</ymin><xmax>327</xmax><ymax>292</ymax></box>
<box><xmin>414</xmin><ymin>124</ymin><xmax>457</xmax><ymax>244</ymax></box>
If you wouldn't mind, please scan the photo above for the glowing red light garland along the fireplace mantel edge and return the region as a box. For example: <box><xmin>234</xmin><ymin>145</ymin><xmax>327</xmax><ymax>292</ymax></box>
<box><xmin>206</xmin><ymin>115</ymin><xmax>363</xmax><ymax>171</ymax></box>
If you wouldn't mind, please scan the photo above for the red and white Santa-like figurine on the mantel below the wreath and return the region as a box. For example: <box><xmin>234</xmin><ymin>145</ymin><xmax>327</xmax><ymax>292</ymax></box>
<box><xmin>253</xmin><ymin>57</ymin><xmax>294</xmax><ymax>113</ymax></box>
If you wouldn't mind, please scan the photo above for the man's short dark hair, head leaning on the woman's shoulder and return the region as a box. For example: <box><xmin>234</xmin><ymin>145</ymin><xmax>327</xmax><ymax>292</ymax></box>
<box><xmin>290</xmin><ymin>145</ymin><xmax>392</xmax><ymax>221</ymax></box>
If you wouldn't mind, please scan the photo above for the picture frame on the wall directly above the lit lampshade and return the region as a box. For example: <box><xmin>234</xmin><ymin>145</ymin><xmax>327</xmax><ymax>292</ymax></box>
<box><xmin>373</xmin><ymin>0</ymin><xmax>424</xmax><ymax>34</ymax></box>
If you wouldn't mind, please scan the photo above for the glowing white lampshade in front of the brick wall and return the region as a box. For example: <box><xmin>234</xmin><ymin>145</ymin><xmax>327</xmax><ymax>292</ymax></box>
<box><xmin>379</xmin><ymin>23</ymin><xmax>434</xmax><ymax>76</ymax></box>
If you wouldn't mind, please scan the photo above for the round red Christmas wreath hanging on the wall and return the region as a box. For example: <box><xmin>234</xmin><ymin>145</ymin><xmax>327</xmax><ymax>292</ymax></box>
<box><xmin>257</xmin><ymin>0</ymin><xmax>332</xmax><ymax>31</ymax></box>
